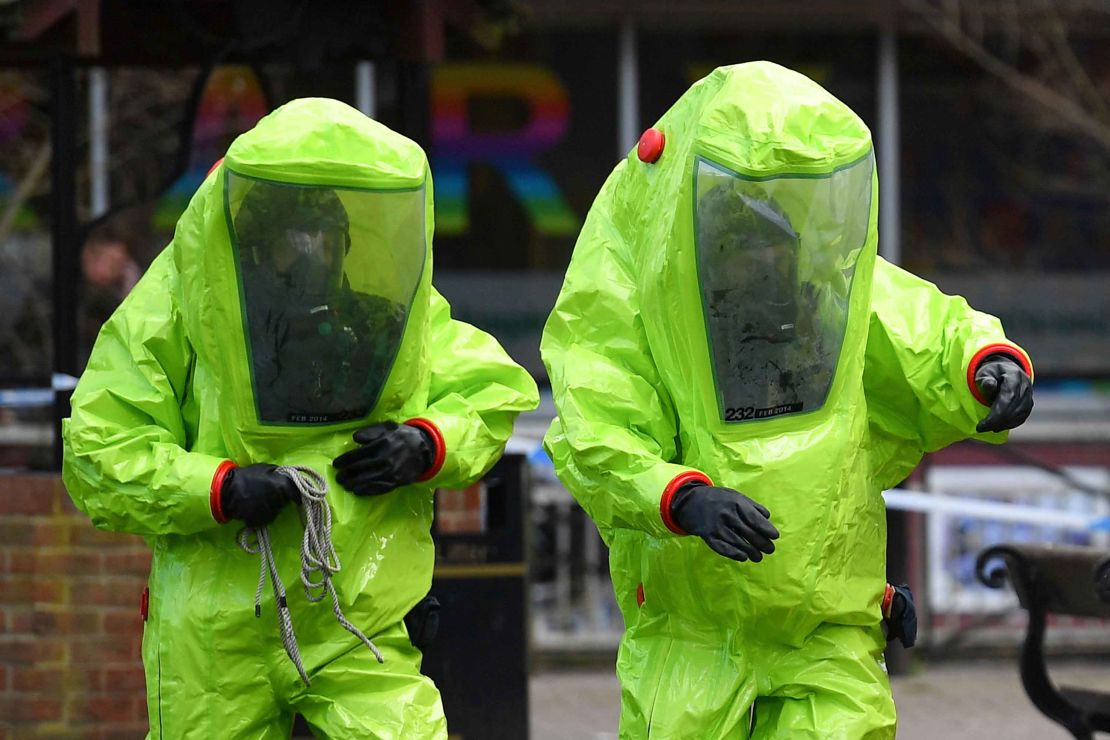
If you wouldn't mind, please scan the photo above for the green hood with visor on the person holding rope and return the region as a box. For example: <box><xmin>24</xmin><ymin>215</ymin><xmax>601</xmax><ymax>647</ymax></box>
<box><xmin>173</xmin><ymin>99</ymin><xmax>432</xmax><ymax>459</ymax></box>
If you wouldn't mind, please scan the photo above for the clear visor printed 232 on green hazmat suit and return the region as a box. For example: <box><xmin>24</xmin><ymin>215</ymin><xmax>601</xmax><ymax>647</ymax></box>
<box><xmin>695</xmin><ymin>156</ymin><xmax>872</xmax><ymax>422</ymax></box>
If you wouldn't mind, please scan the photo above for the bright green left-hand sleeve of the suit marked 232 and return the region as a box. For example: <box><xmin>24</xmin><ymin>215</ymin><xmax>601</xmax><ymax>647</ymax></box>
<box><xmin>541</xmin><ymin>181</ymin><xmax>708</xmax><ymax>536</ymax></box>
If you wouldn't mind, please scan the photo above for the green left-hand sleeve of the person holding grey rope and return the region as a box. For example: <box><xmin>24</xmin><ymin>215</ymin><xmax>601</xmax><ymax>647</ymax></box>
<box><xmin>62</xmin><ymin>250</ymin><xmax>223</xmax><ymax>535</ymax></box>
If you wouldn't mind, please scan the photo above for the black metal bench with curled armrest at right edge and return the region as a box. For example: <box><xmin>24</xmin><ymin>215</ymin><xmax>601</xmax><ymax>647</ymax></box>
<box><xmin>976</xmin><ymin>545</ymin><xmax>1110</xmax><ymax>740</ymax></box>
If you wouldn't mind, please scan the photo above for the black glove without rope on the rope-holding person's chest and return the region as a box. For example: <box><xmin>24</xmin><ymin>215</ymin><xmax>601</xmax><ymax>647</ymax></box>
<box><xmin>332</xmin><ymin>422</ymin><xmax>435</xmax><ymax>496</ymax></box>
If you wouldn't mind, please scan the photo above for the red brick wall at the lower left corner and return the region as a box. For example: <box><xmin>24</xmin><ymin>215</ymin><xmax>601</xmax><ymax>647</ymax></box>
<box><xmin>0</xmin><ymin>475</ymin><xmax>150</xmax><ymax>740</ymax></box>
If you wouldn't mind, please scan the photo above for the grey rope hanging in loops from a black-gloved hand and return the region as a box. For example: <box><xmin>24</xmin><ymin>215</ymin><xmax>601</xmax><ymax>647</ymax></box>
<box><xmin>238</xmin><ymin>466</ymin><xmax>385</xmax><ymax>686</ymax></box>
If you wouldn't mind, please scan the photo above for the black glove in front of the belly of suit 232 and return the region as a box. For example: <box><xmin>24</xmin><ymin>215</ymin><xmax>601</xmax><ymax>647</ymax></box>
<box><xmin>670</xmin><ymin>481</ymin><xmax>778</xmax><ymax>562</ymax></box>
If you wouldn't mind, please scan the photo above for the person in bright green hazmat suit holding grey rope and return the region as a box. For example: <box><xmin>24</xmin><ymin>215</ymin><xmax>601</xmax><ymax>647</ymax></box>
<box><xmin>63</xmin><ymin>99</ymin><xmax>538</xmax><ymax>739</ymax></box>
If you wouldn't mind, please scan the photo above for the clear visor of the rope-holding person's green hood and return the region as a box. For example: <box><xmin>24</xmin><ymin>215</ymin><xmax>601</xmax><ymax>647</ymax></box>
<box><xmin>226</xmin><ymin>171</ymin><xmax>425</xmax><ymax>424</ymax></box>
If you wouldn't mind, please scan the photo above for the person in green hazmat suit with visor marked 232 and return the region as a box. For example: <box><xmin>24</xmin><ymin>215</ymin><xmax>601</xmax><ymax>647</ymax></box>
<box><xmin>542</xmin><ymin>62</ymin><xmax>1032</xmax><ymax>740</ymax></box>
